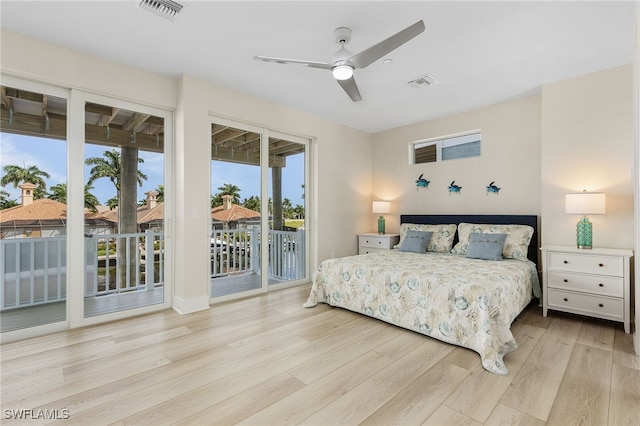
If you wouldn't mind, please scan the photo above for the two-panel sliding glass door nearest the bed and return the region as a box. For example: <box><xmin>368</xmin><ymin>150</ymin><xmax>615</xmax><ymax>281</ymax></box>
<box><xmin>210</xmin><ymin>118</ymin><xmax>309</xmax><ymax>299</ymax></box>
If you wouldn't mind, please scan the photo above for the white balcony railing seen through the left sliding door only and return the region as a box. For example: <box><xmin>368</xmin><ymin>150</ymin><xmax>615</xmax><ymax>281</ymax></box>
<box><xmin>0</xmin><ymin>231</ymin><xmax>164</xmax><ymax>310</ymax></box>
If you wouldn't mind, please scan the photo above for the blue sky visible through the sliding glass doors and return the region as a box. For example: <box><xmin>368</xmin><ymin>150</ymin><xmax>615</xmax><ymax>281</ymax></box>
<box><xmin>0</xmin><ymin>133</ymin><xmax>304</xmax><ymax>206</ymax></box>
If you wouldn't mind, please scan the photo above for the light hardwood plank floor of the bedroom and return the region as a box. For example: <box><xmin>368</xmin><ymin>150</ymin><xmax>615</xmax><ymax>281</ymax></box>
<box><xmin>0</xmin><ymin>286</ymin><xmax>640</xmax><ymax>426</ymax></box>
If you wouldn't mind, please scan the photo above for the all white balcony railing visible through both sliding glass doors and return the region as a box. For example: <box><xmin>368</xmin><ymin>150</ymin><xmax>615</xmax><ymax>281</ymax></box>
<box><xmin>0</xmin><ymin>229</ymin><xmax>305</xmax><ymax>310</ymax></box>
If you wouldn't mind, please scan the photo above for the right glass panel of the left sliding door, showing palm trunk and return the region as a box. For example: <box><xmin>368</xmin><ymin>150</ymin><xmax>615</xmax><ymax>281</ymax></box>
<box><xmin>83</xmin><ymin>97</ymin><xmax>170</xmax><ymax>318</ymax></box>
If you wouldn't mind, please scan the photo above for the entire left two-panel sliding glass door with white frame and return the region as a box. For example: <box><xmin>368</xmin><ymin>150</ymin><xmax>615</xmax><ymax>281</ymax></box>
<box><xmin>0</xmin><ymin>76</ymin><xmax>173</xmax><ymax>341</ymax></box>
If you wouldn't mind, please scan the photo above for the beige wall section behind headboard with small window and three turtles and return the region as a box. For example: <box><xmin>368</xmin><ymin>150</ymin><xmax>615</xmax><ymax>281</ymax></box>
<box><xmin>369</xmin><ymin>96</ymin><xmax>540</xmax><ymax>232</ymax></box>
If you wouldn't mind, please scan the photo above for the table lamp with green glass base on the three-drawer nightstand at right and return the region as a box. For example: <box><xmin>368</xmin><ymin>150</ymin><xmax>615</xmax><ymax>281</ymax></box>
<box><xmin>564</xmin><ymin>190</ymin><xmax>606</xmax><ymax>249</ymax></box>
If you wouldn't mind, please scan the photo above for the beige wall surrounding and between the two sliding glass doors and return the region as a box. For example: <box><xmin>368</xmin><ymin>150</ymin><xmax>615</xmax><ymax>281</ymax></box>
<box><xmin>0</xmin><ymin>29</ymin><xmax>372</xmax><ymax>312</ymax></box>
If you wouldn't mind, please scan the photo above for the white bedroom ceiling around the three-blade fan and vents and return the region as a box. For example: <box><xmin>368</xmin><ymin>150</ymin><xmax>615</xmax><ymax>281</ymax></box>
<box><xmin>0</xmin><ymin>0</ymin><xmax>636</xmax><ymax>132</ymax></box>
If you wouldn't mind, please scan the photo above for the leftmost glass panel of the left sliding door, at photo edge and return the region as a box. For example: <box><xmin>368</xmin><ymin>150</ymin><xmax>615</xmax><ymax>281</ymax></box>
<box><xmin>0</xmin><ymin>79</ymin><xmax>68</xmax><ymax>333</ymax></box>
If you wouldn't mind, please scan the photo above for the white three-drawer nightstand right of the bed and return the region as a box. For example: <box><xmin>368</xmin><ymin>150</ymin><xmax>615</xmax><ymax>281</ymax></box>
<box><xmin>541</xmin><ymin>246</ymin><xmax>633</xmax><ymax>333</ymax></box>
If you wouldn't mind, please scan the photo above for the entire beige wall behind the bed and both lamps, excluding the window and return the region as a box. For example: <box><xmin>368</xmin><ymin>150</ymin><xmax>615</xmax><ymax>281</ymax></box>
<box><xmin>369</xmin><ymin>65</ymin><xmax>634</xmax><ymax>253</ymax></box>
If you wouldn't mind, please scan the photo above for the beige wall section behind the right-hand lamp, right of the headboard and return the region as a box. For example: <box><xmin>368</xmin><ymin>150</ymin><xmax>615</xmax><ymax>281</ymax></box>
<box><xmin>541</xmin><ymin>65</ymin><xmax>634</xmax><ymax>249</ymax></box>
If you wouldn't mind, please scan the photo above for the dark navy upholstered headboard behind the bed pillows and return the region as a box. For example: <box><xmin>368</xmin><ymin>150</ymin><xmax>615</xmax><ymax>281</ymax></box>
<box><xmin>400</xmin><ymin>214</ymin><xmax>540</xmax><ymax>269</ymax></box>
